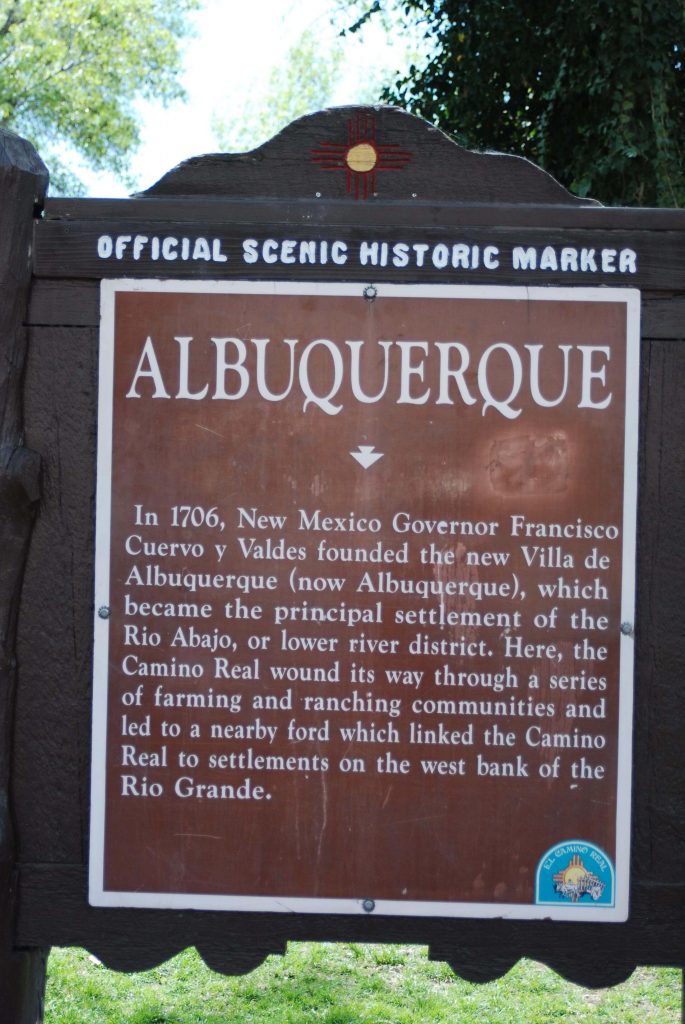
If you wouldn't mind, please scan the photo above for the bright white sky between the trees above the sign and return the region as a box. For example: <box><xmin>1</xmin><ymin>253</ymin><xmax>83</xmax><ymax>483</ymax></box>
<box><xmin>77</xmin><ymin>0</ymin><xmax>417</xmax><ymax>198</ymax></box>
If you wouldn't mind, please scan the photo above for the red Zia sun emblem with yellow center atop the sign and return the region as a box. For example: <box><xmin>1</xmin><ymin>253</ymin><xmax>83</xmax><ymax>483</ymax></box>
<box><xmin>311</xmin><ymin>112</ymin><xmax>412</xmax><ymax>199</ymax></box>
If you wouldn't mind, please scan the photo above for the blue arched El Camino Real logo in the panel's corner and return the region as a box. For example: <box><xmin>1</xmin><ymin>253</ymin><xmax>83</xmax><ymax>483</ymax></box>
<box><xmin>536</xmin><ymin>840</ymin><xmax>614</xmax><ymax>906</ymax></box>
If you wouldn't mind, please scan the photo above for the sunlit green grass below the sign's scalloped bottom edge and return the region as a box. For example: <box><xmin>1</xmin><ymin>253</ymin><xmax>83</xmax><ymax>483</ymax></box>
<box><xmin>45</xmin><ymin>942</ymin><xmax>681</xmax><ymax>1024</ymax></box>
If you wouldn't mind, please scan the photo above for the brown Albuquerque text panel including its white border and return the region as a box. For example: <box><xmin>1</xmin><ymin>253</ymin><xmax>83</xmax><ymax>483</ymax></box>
<box><xmin>90</xmin><ymin>281</ymin><xmax>639</xmax><ymax>922</ymax></box>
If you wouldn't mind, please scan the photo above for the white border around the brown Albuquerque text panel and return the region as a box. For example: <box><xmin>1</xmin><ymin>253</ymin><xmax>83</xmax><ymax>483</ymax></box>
<box><xmin>88</xmin><ymin>279</ymin><xmax>640</xmax><ymax>923</ymax></box>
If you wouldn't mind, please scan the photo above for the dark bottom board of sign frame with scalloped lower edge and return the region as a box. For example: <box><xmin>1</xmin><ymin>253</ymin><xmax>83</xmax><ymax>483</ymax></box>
<box><xmin>15</xmin><ymin>864</ymin><xmax>684</xmax><ymax>986</ymax></box>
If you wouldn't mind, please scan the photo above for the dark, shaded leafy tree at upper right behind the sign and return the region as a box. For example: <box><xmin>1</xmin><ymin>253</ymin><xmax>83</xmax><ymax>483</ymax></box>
<box><xmin>349</xmin><ymin>0</ymin><xmax>685</xmax><ymax>206</ymax></box>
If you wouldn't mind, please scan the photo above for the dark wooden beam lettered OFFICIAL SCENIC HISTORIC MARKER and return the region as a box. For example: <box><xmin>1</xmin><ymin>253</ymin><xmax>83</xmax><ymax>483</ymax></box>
<box><xmin>30</xmin><ymin>220</ymin><xmax>685</xmax><ymax>291</ymax></box>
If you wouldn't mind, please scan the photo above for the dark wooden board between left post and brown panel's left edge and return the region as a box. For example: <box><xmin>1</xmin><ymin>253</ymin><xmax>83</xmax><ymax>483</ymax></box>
<box><xmin>13</xmin><ymin>328</ymin><xmax>97</xmax><ymax>863</ymax></box>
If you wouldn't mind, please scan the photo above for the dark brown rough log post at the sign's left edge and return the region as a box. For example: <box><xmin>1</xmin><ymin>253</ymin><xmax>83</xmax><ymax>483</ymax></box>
<box><xmin>0</xmin><ymin>130</ymin><xmax>47</xmax><ymax>1024</ymax></box>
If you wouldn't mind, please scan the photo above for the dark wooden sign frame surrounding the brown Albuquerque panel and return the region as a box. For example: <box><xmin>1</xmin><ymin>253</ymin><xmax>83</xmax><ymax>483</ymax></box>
<box><xmin>3</xmin><ymin>108</ymin><xmax>685</xmax><ymax>1007</ymax></box>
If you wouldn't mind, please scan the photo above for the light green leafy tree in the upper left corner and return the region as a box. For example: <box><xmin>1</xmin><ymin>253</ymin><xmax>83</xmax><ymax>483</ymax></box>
<box><xmin>0</xmin><ymin>0</ymin><xmax>199</xmax><ymax>191</ymax></box>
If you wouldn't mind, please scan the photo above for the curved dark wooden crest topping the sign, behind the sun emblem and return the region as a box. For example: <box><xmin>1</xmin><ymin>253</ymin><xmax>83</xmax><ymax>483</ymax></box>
<box><xmin>135</xmin><ymin>106</ymin><xmax>593</xmax><ymax>206</ymax></box>
